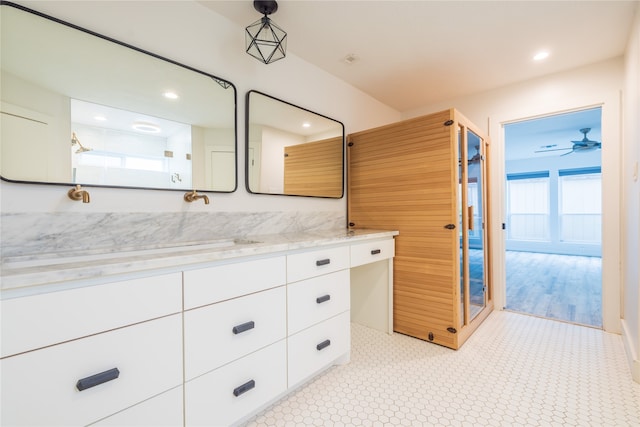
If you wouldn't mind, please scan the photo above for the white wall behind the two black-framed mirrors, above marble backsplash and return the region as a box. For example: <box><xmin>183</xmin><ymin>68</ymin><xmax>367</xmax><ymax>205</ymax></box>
<box><xmin>0</xmin><ymin>0</ymin><xmax>400</xmax><ymax>217</ymax></box>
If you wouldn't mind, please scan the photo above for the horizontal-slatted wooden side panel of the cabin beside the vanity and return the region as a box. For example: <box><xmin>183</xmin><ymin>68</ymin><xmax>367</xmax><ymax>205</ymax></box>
<box><xmin>347</xmin><ymin>110</ymin><xmax>460</xmax><ymax>348</ymax></box>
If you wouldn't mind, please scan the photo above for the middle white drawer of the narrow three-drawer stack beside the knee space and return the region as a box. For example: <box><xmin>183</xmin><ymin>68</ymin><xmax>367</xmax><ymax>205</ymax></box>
<box><xmin>287</xmin><ymin>270</ymin><xmax>350</xmax><ymax>335</ymax></box>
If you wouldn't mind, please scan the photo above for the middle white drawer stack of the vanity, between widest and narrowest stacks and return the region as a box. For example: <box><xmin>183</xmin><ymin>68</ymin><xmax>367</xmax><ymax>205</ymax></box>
<box><xmin>184</xmin><ymin>256</ymin><xmax>287</xmax><ymax>425</ymax></box>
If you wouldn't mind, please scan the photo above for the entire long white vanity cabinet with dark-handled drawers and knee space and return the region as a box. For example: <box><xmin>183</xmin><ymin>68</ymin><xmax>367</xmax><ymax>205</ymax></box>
<box><xmin>0</xmin><ymin>232</ymin><xmax>394</xmax><ymax>427</ymax></box>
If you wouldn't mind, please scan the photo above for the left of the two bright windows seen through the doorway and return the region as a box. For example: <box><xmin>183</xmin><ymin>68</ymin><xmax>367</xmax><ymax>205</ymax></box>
<box><xmin>507</xmin><ymin>171</ymin><xmax>550</xmax><ymax>240</ymax></box>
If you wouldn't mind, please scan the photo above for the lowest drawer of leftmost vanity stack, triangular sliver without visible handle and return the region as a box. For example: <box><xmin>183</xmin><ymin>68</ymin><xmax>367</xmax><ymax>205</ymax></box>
<box><xmin>91</xmin><ymin>386</ymin><xmax>183</xmax><ymax>427</ymax></box>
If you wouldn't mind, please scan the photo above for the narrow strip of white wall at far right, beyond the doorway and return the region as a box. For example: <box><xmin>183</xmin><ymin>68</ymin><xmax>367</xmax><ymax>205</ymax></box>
<box><xmin>621</xmin><ymin>5</ymin><xmax>640</xmax><ymax>382</ymax></box>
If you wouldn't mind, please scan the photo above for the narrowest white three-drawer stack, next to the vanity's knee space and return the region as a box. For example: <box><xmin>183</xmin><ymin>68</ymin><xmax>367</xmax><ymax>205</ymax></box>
<box><xmin>287</xmin><ymin>246</ymin><xmax>351</xmax><ymax>387</ymax></box>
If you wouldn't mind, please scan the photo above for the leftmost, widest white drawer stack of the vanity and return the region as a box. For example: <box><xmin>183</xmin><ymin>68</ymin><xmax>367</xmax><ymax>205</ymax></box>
<box><xmin>0</xmin><ymin>273</ymin><xmax>183</xmax><ymax>426</ymax></box>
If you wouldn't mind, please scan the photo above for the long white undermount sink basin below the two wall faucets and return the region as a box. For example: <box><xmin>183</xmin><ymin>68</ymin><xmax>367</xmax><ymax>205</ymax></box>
<box><xmin>2</xmin><ymin>239</ymin><xmax>261</xmax><ymax>269</ymax></box>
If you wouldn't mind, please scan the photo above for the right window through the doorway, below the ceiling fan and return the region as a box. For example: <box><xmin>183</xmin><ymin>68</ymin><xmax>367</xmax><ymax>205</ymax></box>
<box><xmin>558</xmin><ymin>167</ymin><xmax>602</xmax><ymax>243</ymax></box>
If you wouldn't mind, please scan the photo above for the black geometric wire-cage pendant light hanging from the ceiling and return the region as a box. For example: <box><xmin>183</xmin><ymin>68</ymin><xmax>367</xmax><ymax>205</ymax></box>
<box><xmin>245</xmin><ymin>0</ymin><xmax>287</xmax><ymax>64</ymax></box>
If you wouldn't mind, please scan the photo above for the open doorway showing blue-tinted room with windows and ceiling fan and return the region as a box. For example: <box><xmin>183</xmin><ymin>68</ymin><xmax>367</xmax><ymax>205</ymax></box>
<box><xmin>505</xmin><ymin>107</ymin><xmax>602</xmax><ymax>328</ymax></box>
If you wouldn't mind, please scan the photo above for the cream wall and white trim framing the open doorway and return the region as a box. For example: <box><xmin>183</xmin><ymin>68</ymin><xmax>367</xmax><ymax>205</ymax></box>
<box><xmin>403</xmin><ymin>58</ymin><xmax>624</xmax><ymax>333</ymax></box>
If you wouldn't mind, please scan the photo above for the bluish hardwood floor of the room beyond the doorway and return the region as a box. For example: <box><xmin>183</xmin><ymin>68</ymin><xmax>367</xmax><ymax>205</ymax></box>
<box><xmin>505</xmin><ymin>251</ymin><xmax>602</xmax><ymax>328</ymax></box>
